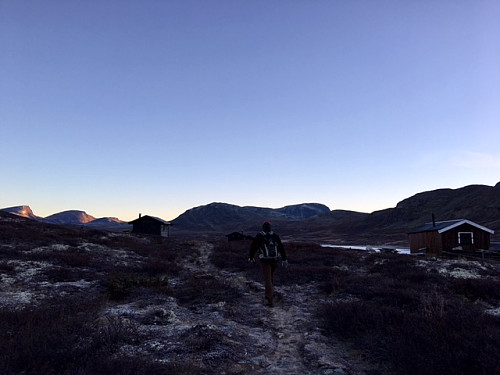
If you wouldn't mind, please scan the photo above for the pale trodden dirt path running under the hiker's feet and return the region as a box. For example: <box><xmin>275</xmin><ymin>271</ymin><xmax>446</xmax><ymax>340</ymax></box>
<box><xmin>184</xmin><ymin>243</ymin><xmax>376</xmax><ymax>375</ymax></box>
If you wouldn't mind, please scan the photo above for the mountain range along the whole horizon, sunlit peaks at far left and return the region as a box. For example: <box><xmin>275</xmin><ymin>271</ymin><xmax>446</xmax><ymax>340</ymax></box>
<box><xmin>2</xmin><ymin>182</ymin><xmax>500</xmax><ymax>245</ymax></box>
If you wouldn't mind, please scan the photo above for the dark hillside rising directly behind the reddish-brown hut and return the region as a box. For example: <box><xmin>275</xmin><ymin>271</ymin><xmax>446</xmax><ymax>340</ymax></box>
<box><xmin>311</xmin><ymin>183</ymin><xmax>500</xmax><ymax>244</ymax></box>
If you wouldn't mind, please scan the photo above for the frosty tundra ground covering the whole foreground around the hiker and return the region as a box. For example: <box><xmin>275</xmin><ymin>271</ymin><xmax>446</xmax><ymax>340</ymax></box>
<box><xmin>0</xmin><ymin>216</ymin><xmax>500</xmax><ymax>375</ymax></box>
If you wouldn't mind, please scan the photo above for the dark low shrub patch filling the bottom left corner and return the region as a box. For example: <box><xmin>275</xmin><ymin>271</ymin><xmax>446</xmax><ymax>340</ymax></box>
<box><xmin>0</xmin><ymin>294</ymin><xmax>201</xmax><ymax>375</ymax></box>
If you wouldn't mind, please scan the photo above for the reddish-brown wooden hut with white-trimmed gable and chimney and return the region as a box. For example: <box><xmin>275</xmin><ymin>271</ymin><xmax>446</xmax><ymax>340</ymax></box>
<box><xmin>408</xmin><ymin>219</ymin><xmax>495</xmax><ymax>256</ymax></box>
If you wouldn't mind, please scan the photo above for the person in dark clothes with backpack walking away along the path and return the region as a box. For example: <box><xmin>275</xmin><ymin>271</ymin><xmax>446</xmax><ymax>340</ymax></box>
<box><xmin>248</xmin><ymin>221</ymin><xmax>288</xmax><ymax>307</ymax></box>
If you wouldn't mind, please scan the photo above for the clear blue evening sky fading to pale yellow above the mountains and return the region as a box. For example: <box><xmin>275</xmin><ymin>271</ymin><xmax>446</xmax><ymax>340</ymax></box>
<box><xmin>0</xmin><ymin>0</ymin><xmax>500</xmax><ymax>220</ymax></box>
